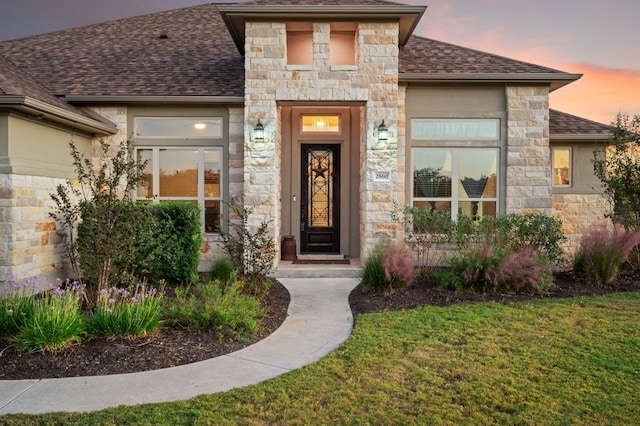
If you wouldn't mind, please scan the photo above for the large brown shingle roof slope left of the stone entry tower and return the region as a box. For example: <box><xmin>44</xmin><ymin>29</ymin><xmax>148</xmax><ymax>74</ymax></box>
<box><xmin>0</xmin><ymin>5</ymin><xmax>244</xmax><ymax>96</ymax></box>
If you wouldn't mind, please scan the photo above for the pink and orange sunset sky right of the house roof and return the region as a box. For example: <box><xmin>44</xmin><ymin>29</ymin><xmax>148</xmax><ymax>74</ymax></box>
<box><xmin>420</xmin><ymin>0</ymin><xmax>640</xmax><ymax>124</ymax></box>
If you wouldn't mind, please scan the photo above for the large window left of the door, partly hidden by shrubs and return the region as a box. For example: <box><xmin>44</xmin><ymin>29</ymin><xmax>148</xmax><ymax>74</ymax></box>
<box><xmin>136</xmin><ymin>147</ymin><xmax>223</xmax><ymax>233</ymax></box>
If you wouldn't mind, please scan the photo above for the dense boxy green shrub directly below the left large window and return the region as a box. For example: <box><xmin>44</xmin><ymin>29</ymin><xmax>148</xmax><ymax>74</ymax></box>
<box><xmin>140</xmin><ymin>201</ymin><xmax>202</xmax><ymax>285</ymax></box>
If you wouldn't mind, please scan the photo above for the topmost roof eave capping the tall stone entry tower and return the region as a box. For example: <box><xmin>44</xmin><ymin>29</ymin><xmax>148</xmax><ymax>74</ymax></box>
<box><xmin>216</xmin><ymin>4</ymin><xmax>427</xmax><ymax>55</ymax></box>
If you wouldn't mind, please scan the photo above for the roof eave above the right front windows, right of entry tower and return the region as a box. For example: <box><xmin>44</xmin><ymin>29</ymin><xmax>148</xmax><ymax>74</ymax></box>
<box><xmin>398</xmin><ymin>72</ymin><xmax>582</xmax><ymax>92</ymax></box>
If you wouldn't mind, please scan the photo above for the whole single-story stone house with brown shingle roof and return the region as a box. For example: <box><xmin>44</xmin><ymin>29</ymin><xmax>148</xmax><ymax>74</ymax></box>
<box><xmin>0</xmin><ymin>0</ymin><xmax>608</xmax><ymax>286</ymax></box>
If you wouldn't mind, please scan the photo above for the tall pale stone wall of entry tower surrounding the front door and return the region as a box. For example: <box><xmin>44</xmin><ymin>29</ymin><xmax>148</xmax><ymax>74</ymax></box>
<box><xmin>244</xmin><ymin>22</ymin><xmax>404</xmax><ymax>258</ymax></box>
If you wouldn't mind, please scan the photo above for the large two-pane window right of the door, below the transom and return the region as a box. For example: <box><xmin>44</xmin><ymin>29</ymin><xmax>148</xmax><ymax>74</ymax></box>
<box><xmin>412</xmin><ymin>148</ymin><xmax>498</xmax><ymax>220</ymax></box>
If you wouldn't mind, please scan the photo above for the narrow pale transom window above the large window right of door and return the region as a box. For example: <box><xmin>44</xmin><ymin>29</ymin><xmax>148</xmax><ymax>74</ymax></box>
<box><xmin>411</xmin><ymin>118</ymin><xmax>500</xmax><ymax>140</ymax></box>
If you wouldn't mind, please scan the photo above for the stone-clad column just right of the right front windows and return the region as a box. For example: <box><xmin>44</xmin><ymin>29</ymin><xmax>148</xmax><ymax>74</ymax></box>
<box><xmin>506</xmin><ymin>86</ymin><xmax>553</xmax><ymax>216</ymax></box>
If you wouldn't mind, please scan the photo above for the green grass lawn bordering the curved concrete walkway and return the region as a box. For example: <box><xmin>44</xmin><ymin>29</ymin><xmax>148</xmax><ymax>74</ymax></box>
<box><xmin>5</xmin><ymin>293</ymin><xmax>640</xmax><ymax>425</ymax></box>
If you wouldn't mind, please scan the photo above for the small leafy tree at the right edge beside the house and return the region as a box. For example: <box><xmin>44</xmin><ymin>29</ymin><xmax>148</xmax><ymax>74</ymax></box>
<box><xmin>593</xmin><ymin>114</ymin><xmax>640</xmax><ymax>231</ymax></box>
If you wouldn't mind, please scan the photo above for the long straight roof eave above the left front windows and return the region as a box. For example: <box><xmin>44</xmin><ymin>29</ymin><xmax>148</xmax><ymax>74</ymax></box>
<box><xmin>64</xmin><ymin>95</ymin><xmax>244</xmax><ymax>105</ymax></box>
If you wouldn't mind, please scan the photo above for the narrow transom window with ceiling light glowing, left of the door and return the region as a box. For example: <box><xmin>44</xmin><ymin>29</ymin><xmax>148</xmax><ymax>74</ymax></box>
<box><xmin>134</xmin><ymin>117</ymin><xmax>222</xmax><ymax>139</ymax></box>
